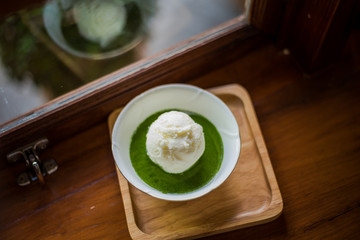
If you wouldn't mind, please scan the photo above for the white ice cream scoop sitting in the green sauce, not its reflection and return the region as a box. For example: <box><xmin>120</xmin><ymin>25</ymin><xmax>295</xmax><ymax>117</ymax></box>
<box><xmin>146</xmin><ymin>111</ymin><xmax>205</xmax><ymax>173</ymax></box>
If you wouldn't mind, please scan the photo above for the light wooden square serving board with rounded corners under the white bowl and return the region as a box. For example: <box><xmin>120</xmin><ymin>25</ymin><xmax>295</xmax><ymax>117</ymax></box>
<box><xmin>108</xmin><ymin>84</ymin><xmax>283</xmax><ymax>239</ymax></box>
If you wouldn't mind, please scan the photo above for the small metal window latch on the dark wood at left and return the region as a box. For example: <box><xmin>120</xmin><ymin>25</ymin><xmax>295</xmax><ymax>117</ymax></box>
<box><xmin>7</xmin><ymin>138</ymin><xmax>58</xmax><ymax>186</ymax></box>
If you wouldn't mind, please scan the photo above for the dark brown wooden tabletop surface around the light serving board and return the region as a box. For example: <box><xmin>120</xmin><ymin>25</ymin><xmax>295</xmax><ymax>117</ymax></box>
<box><xmin>0</xmin><ymin>31</ymin><xmax>360</xmax><ymax>239</ymax></box>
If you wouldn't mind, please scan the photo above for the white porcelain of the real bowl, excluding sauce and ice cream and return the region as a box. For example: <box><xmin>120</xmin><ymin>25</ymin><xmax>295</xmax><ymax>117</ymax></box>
<box><xmin>112</xmin><ymin>84</ymin><xmax>240</xmax><ymax>201</ymax></box>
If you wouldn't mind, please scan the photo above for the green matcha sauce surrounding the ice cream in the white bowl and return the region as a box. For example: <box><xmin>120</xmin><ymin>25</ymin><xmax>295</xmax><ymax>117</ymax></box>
<box><xmin>130</xmin><ymin>109</ymin><xmax>223</xmax><ymax>193</ymax></box>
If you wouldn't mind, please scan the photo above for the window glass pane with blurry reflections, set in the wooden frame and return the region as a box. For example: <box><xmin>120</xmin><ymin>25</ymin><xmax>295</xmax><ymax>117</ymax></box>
<box><xmin>0</xmin><ymin>0</ymin><xmax>246</xmax><ymax>125</ymax></box>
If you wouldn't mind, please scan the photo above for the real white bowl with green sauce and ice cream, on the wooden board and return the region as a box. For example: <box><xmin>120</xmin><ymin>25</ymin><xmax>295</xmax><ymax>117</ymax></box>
<box><xmin>112</xmin><ymin>84</ymin><xmax>241</xmax><ymax>201</ymax></box>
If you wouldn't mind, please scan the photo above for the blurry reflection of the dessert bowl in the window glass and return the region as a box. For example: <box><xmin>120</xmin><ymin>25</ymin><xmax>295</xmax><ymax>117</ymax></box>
<box><xmin>43</xmin><ymin>0</ymin><xmax>150</xmax><ymax>60</ymax></box>
